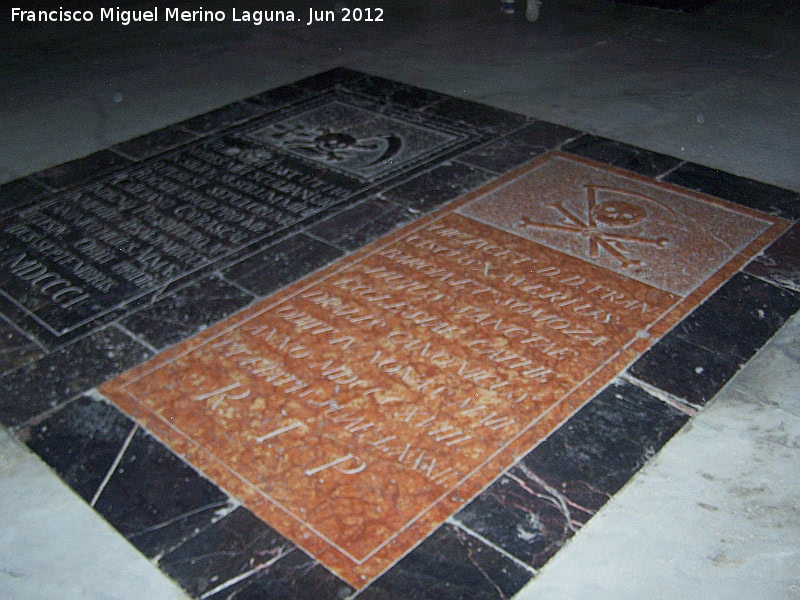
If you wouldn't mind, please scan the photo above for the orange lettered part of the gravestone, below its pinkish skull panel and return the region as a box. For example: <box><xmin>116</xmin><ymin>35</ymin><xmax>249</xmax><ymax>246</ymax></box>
<box><xmin>103</xmin><ymin>214</ymin><xmax>675</xmax><ymax>580</ymax></box>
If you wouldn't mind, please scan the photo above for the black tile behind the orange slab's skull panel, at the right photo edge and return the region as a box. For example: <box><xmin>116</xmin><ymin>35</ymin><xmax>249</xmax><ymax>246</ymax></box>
<box><xmin>664</xmin><ymin>163</ymin><xmax>800</xmax><ymax>219</ymax></box>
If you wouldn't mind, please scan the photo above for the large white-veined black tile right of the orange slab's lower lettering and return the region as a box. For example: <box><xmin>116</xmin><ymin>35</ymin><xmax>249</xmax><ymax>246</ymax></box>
<box><xmin>455</xmin><ymin>381</ymin><xmax>688</xmax><ymax>568</ymax></box>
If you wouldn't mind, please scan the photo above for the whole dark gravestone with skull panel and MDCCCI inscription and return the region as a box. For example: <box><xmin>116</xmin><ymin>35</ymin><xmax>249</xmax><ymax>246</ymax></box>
<box><xmin>0</xmin><ymin>78</ymin><xmax>488</xmax><ymax>343</ymax></box>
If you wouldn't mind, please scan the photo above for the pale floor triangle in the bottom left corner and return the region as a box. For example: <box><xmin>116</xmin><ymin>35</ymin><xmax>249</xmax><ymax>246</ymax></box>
<box><xmin>0</xmin><ymin>431</ymin><xmax>188</xmax><ymax>600</ymax></box>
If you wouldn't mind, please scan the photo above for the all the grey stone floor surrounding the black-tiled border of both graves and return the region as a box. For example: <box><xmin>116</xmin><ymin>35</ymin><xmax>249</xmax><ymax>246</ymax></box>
<box><xmin>0</xmin><ymin>0</ymin><xmax>800</xmax><ymax>599</ymax></box>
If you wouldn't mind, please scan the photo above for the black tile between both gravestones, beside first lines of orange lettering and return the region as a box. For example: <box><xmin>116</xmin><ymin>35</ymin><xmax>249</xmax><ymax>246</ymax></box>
<box><xmin>308</xmin><ymin>198</ymin><xmax>419</xmax><ymax>251</ymax></box>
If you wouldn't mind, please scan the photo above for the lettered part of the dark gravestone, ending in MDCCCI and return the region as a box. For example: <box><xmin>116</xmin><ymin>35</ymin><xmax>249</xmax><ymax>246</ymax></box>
<box><xmin>0</xmin><ymin>135</ymin><xmax>352</xmax><ymax>335</ymax></box>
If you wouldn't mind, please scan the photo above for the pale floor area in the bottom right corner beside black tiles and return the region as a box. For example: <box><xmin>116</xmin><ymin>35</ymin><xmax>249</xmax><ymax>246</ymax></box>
<box><xmin>517</xmin><ymin>317</ymin><xmax>800</xmax><ymax>600</ymax></box>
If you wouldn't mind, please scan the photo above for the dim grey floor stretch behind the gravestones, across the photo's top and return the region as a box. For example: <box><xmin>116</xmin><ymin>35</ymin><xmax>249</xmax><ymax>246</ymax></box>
<box><xmin>0</xmin><ymin>0</ymin><xmax>800</xmax><ymax>190</ymax></box>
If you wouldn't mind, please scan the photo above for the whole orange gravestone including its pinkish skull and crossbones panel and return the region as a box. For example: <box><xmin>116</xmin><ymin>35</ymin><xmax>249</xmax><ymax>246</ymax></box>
<box><xmin>101</xmin><ymin>154</ymin><xmax>786</xmax><ymax>587</ymax></box>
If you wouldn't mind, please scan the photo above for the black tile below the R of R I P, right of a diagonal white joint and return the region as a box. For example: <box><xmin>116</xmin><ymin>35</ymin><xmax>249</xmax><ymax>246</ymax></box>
<box><xmin>94</xmin><ymin>429</ymin><xmax>231</xmax><ymax>558</ymax></box>
